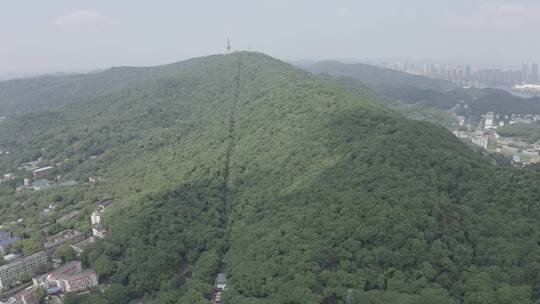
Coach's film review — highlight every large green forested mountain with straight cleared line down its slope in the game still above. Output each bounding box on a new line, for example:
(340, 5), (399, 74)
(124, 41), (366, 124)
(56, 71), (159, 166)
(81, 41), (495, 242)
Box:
(0, 52), (540, 304)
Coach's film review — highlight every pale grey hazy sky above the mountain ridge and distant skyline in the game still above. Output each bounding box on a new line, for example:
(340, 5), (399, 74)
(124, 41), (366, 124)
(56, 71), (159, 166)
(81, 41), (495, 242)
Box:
(0, 0), (540, 74)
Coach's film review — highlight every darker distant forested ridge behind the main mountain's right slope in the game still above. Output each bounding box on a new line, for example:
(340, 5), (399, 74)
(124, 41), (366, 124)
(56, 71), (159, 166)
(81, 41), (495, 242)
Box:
(306, 61), (540, 115)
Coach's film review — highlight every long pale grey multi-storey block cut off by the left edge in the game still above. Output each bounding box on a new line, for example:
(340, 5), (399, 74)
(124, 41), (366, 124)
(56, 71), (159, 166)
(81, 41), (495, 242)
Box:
(0, 251), (48, 288)
